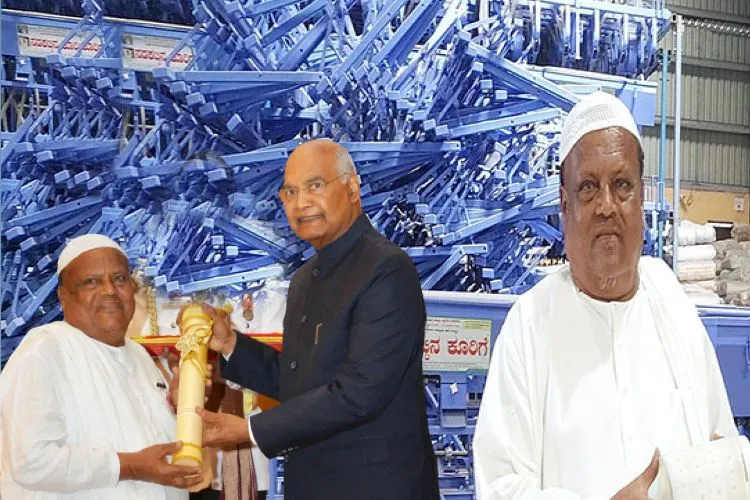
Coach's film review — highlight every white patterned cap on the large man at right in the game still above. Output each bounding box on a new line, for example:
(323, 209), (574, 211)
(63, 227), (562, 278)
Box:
(560, 91), (643, 163)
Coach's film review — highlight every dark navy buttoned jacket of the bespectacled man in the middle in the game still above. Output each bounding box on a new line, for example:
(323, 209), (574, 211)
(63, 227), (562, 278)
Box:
(221, 215), (439, 500)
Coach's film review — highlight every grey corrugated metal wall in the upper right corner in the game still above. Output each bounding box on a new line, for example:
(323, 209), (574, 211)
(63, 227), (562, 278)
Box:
(644, 0), (750, 187)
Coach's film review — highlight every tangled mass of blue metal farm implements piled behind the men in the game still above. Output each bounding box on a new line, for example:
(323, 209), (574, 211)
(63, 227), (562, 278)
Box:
(0, 0), (669, 360)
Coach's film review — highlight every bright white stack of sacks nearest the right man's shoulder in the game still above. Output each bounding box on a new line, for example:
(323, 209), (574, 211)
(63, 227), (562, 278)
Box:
(677, 220), (722, 304)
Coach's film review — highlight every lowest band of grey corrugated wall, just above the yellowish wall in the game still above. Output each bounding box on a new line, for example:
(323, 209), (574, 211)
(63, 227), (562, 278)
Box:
(643, 127), (750, 187)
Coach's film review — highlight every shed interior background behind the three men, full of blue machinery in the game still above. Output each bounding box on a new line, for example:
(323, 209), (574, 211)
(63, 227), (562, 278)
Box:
(0, 0), (750, 500)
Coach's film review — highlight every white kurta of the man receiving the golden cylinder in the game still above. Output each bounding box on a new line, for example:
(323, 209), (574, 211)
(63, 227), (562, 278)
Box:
(0, 322), (188, 500)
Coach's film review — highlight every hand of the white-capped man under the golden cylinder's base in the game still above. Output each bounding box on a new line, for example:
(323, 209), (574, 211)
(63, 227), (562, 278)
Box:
(117, 441), (203, 488)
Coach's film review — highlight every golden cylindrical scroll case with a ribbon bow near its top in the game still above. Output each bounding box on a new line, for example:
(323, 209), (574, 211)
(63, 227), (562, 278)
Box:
(172, 305), (213, 467)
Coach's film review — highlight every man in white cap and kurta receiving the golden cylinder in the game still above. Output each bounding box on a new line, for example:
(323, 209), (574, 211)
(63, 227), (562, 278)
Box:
(0, 234), (201, 500)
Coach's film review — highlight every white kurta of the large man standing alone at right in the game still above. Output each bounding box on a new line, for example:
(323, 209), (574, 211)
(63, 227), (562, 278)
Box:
(474, 258), (737, 500)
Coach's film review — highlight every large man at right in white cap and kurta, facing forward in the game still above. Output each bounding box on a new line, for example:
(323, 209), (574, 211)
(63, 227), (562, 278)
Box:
(474, 92), (737, 500)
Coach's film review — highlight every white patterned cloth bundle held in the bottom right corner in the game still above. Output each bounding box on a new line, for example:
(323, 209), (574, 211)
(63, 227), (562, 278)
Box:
(657, 436), (750, 500)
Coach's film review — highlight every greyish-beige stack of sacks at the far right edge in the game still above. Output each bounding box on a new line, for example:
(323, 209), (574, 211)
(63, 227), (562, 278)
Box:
(714, 224), (750, 306)
